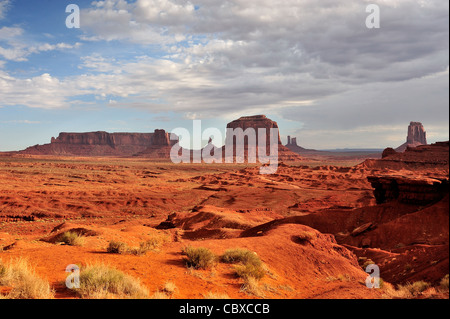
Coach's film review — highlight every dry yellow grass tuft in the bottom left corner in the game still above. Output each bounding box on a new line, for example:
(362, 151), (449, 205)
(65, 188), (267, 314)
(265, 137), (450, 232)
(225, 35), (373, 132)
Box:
(0, 258), (54, 299)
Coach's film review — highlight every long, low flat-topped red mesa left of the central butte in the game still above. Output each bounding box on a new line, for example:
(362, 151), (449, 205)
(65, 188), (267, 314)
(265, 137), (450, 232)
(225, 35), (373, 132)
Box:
(20, 130), (173, 157)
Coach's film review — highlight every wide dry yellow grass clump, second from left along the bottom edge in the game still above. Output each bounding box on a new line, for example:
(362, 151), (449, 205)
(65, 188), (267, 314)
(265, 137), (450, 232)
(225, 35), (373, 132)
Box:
(76, 264), (148, 299)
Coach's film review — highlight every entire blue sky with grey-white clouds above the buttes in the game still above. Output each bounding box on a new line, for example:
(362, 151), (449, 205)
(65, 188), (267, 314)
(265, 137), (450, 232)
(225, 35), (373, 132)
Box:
(0, 0), (449, 151)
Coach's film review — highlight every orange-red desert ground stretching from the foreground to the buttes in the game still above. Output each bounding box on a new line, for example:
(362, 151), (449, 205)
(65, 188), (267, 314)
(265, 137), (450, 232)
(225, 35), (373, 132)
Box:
(0, 145), (448, 298)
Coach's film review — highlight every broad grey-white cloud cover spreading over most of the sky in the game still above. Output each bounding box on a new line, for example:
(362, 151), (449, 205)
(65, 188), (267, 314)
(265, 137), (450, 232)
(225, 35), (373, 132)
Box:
(0, 0), (449, 147)
